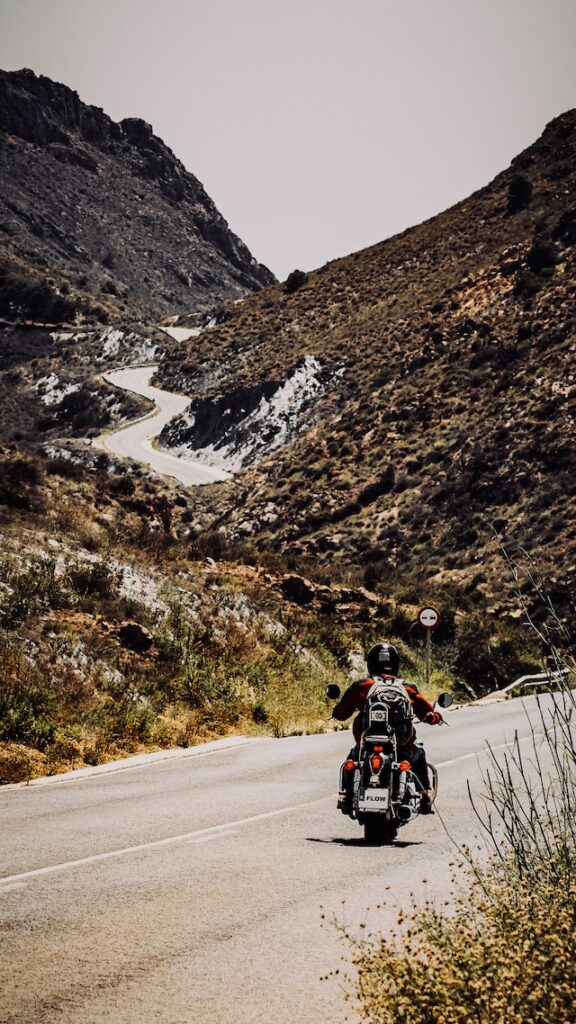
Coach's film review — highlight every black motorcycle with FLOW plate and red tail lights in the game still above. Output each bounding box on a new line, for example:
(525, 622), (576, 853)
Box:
(326, 683), (452, 846)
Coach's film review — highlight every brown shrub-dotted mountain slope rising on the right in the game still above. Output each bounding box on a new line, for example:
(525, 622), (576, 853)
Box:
(155, 112), (576, 606)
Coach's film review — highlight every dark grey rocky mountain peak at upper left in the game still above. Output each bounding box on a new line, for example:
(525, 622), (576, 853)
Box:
(0, 71), (274, 316)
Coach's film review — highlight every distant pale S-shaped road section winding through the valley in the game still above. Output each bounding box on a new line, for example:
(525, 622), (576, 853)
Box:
(93, 367), (231, 486)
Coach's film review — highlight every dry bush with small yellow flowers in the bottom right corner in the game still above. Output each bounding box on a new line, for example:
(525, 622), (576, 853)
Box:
(357, 862), (576, 1024)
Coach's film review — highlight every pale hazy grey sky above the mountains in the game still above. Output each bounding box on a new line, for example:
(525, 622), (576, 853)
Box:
(0, 0), (576, 279)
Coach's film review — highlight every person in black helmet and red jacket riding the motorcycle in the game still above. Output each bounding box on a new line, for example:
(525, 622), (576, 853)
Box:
(332, 642), (442, 814)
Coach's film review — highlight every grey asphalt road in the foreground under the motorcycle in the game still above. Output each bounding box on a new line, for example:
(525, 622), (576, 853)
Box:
(0, 697), (549, 1024)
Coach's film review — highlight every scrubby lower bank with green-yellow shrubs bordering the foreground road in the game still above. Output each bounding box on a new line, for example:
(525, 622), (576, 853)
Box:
(0, 445), (539, 782)
